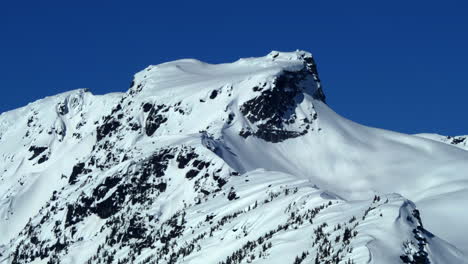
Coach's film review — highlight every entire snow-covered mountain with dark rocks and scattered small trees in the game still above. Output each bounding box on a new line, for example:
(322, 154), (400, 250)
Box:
(0, 51), (468, 264)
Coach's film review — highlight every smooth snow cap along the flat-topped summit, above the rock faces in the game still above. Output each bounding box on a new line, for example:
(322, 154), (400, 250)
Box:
(129, 50), (325, 101)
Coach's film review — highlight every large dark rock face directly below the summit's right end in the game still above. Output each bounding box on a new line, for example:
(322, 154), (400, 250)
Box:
(240, 69), (325, 143)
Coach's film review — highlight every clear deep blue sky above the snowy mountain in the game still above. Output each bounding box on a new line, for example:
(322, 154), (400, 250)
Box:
(0, 0), (468, 135)
